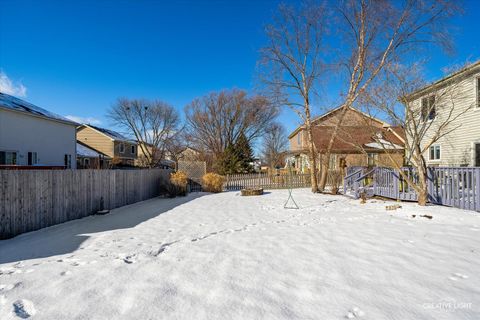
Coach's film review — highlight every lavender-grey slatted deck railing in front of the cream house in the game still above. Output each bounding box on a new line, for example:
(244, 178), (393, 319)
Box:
(344, 167), (480, 211)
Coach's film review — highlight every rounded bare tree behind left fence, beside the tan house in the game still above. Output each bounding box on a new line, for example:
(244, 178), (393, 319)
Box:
(108, 98), (180, 167)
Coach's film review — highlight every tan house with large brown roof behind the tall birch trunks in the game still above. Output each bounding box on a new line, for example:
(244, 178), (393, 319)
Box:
(288, 108), (405, 172)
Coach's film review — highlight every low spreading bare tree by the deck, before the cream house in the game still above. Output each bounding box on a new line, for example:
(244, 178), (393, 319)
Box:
(363, 64), (475, 205)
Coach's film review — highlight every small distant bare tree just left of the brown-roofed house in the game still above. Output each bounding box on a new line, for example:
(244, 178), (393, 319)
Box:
(262, 123), (288, 169)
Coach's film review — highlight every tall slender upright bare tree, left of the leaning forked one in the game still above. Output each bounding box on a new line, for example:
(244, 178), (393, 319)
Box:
(260, 2), (326, 192)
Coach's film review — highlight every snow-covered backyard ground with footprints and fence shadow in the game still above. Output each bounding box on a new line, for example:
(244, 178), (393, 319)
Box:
(0, 189), (480, 320)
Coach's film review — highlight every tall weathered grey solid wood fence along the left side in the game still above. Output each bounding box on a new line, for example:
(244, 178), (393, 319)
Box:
(0, 169), (170, 239)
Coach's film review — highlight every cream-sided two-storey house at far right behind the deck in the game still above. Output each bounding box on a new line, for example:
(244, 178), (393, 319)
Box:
(408, 61), (480, 167)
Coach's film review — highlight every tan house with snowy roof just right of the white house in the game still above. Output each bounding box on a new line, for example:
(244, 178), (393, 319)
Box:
(77, 124), (137, 166)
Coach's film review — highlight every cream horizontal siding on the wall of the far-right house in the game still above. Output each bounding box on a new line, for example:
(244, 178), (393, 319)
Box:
(413, 70), (480, 166)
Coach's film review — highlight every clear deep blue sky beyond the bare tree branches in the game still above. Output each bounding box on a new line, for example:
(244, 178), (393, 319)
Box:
(0, 0), (480, 130)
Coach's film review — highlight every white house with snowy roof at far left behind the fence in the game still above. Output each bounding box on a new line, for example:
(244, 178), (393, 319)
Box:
(0, 93), (78, 169)
